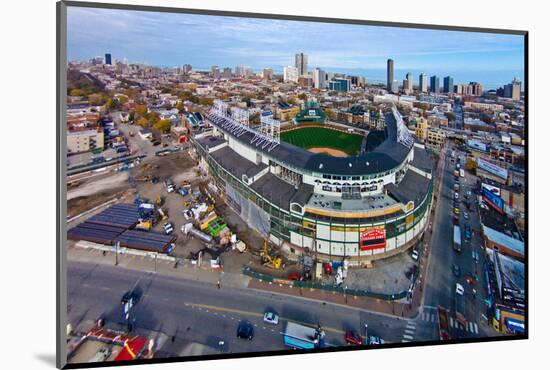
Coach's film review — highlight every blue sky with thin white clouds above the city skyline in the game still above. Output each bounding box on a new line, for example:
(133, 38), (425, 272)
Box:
(67, 7), (524, 87)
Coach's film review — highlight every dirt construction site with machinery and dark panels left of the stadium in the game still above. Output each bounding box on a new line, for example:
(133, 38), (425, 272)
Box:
(67, 145), (307, 279)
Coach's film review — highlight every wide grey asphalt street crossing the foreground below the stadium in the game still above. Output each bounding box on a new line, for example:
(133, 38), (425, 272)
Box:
(68, 261), (436, 355)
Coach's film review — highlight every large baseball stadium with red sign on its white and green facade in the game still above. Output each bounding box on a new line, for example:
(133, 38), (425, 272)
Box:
(191, 101), (433, 264)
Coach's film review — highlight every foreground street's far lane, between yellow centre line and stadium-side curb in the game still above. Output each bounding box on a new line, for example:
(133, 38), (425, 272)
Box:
(69, 263), (414, 344)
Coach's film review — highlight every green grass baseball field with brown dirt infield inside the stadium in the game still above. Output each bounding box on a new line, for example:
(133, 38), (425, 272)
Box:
(281, 127), (363, 156)
